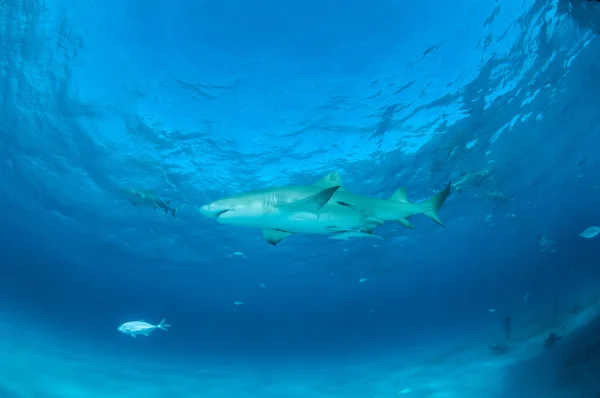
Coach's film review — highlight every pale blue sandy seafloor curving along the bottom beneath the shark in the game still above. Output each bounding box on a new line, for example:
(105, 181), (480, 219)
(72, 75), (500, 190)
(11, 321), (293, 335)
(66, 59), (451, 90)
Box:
(0, 292), (600, 398)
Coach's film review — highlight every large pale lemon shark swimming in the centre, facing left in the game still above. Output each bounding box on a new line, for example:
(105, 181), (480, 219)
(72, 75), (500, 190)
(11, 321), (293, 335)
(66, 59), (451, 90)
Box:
(199, 171), (450, 245)
